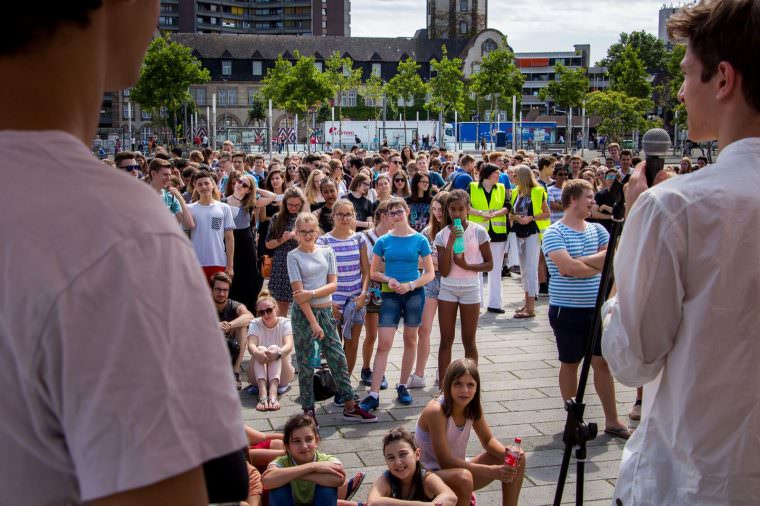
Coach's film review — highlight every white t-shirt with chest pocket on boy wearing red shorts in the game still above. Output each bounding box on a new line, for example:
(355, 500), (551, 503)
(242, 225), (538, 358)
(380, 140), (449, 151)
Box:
(188, 201), (235, 267)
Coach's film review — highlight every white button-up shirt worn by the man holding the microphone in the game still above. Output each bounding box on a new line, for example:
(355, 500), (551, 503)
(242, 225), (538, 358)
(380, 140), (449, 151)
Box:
(602, 138), (760, 506)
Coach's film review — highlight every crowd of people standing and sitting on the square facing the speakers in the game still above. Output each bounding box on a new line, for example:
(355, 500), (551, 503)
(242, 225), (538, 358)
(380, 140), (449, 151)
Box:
(114, 136), (701, 506)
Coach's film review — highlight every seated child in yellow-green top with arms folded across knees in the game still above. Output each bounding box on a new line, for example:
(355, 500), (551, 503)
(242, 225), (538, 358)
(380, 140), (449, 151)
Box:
(261, 415), (364, 506)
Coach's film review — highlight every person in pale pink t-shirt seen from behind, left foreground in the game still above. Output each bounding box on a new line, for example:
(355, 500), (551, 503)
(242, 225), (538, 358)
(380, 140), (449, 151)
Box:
(0, 0), (248, 506)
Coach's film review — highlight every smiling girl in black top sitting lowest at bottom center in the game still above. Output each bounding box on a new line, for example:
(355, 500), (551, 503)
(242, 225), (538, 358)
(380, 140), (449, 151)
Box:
(367, 427), (457, 506)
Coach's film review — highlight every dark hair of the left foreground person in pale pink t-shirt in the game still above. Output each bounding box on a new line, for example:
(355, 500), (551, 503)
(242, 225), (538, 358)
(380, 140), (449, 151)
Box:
(0, 0), (103, 56)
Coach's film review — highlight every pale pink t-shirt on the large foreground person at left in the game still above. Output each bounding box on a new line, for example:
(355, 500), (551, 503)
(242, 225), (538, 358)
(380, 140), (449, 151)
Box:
(0, 131), (246, 505)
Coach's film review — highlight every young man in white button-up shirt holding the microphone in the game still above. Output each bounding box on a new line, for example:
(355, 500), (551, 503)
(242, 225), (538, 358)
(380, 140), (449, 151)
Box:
(602, 0), (760, 506)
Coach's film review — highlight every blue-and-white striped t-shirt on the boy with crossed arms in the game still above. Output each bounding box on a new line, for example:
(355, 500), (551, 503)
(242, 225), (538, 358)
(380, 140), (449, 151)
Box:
(541, 222), (610, 307)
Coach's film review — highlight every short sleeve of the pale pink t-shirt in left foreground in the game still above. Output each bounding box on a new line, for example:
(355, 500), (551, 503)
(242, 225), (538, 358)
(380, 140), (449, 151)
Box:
(40, 233), (246, 502)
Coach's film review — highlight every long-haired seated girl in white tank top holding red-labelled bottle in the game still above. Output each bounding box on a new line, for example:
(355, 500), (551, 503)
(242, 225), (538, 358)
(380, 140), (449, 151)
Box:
(415, 358), (525, 506)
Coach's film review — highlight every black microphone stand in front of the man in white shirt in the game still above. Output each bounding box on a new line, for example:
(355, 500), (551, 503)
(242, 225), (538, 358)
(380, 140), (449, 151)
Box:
(554, 196), (625, 506)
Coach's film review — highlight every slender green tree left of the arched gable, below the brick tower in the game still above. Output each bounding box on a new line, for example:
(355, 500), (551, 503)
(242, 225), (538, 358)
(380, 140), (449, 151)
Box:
(425, 46), (464, 145)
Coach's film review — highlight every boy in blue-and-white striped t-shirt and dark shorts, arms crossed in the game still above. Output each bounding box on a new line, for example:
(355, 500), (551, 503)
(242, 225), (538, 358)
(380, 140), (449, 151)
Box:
(542, 179), (631, 439)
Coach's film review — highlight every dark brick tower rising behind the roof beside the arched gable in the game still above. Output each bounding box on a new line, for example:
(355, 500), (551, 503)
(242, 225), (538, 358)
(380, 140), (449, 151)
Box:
(427, 0), (488, 39)
